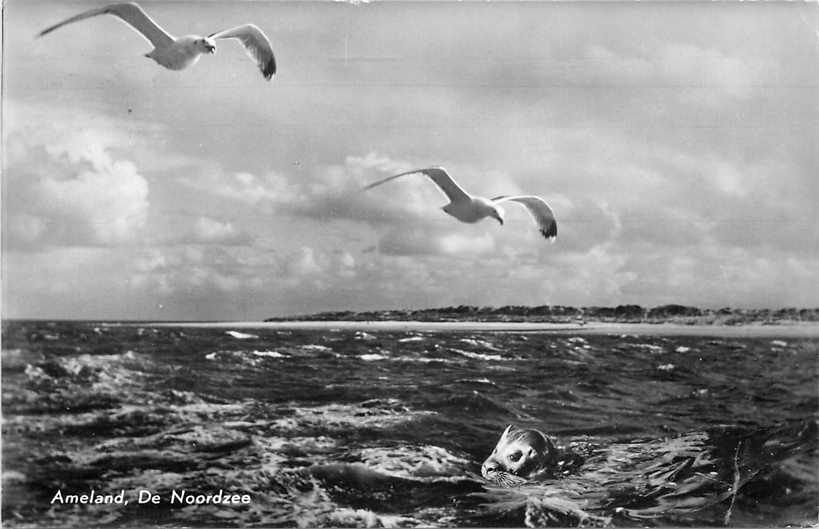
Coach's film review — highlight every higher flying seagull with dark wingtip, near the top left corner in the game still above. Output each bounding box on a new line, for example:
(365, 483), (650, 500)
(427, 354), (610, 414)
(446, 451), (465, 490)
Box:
(37, 2), (276, 81)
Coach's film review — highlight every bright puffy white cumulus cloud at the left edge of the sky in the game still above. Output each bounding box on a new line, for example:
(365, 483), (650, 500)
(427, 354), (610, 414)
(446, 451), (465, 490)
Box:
(3, 106), (149, 249)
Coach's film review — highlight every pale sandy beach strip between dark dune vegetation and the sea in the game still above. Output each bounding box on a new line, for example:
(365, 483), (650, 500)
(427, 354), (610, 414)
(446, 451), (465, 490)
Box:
(120, 320), (819, 338)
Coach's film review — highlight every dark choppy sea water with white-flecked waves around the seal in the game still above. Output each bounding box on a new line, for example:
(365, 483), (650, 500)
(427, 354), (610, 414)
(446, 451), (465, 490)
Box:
(2, 322), (819, 527)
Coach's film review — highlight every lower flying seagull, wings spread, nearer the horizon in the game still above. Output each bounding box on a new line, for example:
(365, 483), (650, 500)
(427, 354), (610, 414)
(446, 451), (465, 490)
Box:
(362, 167), (557, 240)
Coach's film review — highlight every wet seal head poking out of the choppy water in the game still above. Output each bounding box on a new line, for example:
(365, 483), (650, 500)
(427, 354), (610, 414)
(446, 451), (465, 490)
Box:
(481, 424), (557, 485)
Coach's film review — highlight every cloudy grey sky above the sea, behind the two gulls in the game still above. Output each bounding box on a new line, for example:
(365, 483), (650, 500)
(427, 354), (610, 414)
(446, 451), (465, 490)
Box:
(2, 0), (819, 320)
